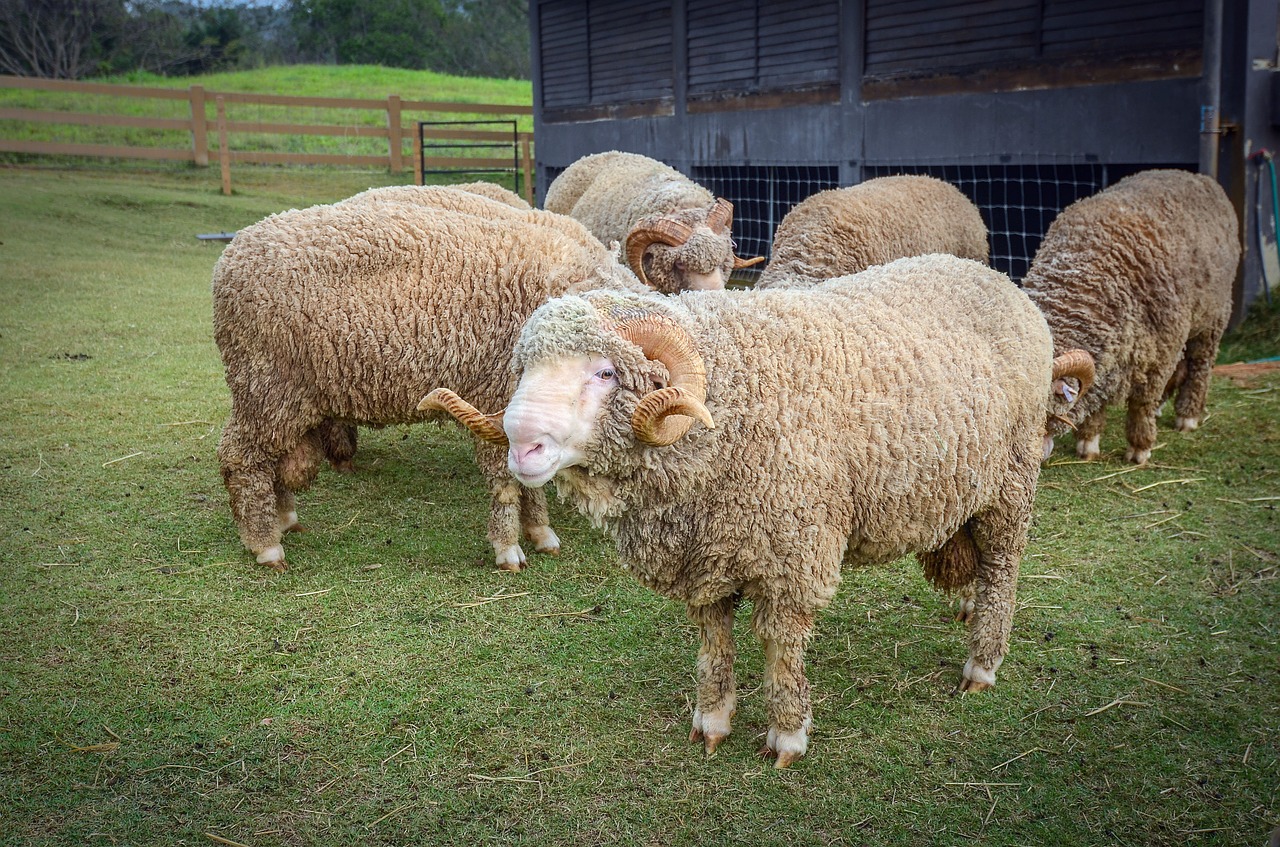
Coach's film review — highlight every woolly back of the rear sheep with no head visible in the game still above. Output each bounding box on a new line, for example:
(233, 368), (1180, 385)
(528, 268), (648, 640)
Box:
(755, 177), (988, 288)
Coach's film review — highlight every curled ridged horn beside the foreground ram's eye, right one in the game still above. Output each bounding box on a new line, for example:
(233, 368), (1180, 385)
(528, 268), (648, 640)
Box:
(612, 315), (716, 447)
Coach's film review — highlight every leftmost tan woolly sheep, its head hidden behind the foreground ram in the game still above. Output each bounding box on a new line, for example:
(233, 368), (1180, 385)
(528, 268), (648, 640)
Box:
(212, 198), (641, 571)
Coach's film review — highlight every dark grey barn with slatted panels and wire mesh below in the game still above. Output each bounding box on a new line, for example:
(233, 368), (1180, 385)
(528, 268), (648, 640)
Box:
(530, 0), (1280, 319)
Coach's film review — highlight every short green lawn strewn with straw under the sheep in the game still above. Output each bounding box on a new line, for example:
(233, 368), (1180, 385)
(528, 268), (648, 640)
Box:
(0, 169), (1280, 847)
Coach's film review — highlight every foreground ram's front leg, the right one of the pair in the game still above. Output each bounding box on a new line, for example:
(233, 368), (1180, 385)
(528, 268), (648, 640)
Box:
(751, 601), (814, 768)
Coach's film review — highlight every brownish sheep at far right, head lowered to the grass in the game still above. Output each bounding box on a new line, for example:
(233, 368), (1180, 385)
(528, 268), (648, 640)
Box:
(1023, 170), (1240, 464)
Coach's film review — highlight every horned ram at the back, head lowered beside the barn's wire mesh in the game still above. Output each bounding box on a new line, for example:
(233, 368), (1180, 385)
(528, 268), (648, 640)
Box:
(543, 150), (764, 294)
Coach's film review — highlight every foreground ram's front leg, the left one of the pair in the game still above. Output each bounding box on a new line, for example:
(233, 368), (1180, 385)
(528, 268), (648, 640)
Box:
(689, 598), (737, 756)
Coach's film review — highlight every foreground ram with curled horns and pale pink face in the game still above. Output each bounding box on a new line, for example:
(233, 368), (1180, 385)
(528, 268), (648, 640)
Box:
(424, 255), (1090, 768)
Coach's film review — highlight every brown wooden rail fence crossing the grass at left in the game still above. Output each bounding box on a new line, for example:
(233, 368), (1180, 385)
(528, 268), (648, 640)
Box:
(0, 75), (534, 203)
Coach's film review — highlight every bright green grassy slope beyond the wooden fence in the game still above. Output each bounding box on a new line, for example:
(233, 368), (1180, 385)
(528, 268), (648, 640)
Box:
(0, 65), (532, 170)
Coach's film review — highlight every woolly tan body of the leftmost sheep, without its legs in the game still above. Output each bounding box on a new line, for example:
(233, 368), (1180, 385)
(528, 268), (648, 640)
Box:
(212, 199), (608, 435)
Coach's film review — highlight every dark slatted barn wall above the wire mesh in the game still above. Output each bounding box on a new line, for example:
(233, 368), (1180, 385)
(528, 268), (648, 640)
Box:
(530, 0), (1280, 314)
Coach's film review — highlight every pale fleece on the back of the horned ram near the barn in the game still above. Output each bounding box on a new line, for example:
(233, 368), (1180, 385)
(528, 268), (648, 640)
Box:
(543, 150), (716, 244)
